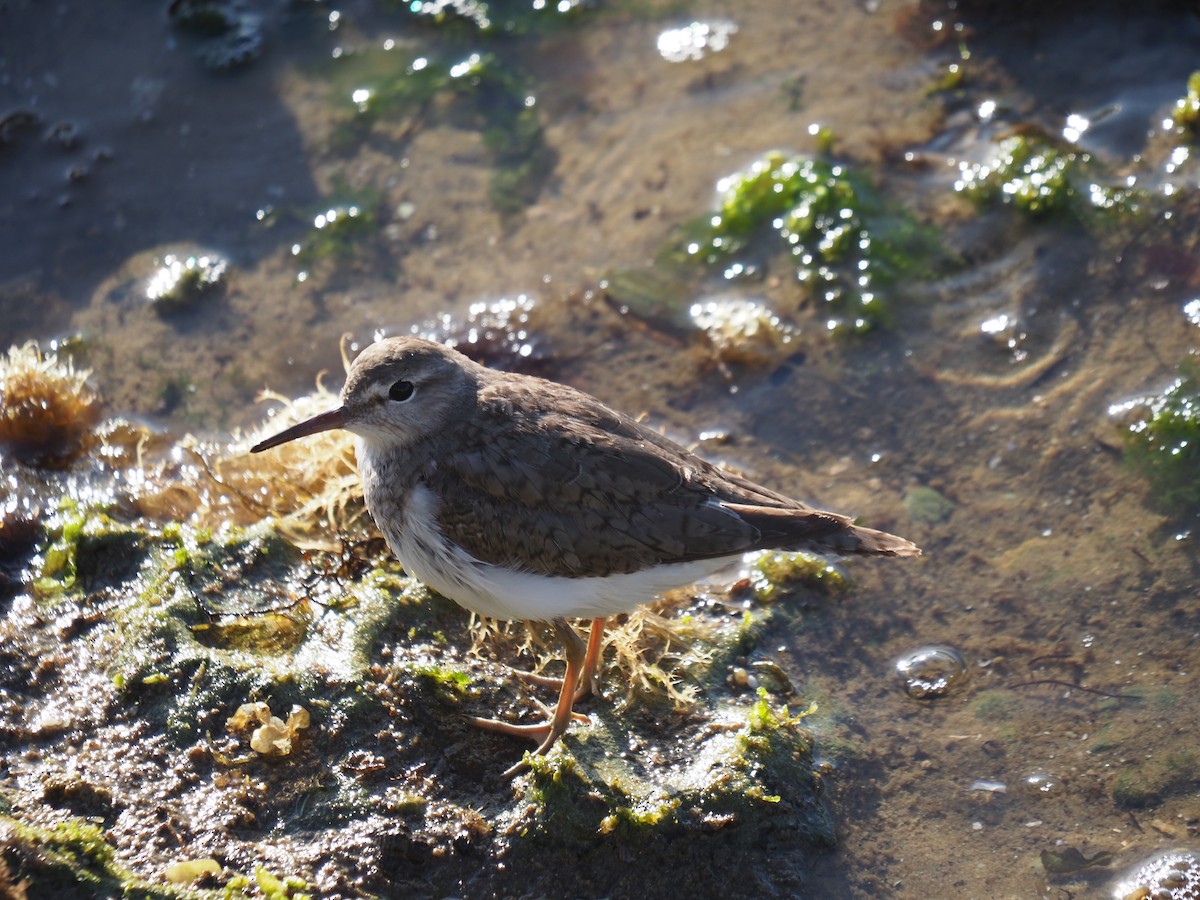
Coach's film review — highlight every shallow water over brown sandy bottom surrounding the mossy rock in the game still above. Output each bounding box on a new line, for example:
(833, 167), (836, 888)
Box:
(7, 0), (1200, 898)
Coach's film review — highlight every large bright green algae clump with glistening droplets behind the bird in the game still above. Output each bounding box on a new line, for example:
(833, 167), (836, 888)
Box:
(667, 151), (937, 335)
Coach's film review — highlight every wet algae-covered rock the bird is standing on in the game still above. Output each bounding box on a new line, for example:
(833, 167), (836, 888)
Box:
(0, 343), (840, 896)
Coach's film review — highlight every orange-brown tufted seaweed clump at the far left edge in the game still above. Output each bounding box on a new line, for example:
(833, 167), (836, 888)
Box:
(0, 341), (100, 468)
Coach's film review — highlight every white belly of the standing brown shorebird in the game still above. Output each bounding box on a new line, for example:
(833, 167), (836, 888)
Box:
(380, 485), (740, 620)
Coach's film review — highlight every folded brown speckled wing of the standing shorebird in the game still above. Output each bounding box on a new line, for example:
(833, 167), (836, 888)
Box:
(426, 380), (871, 577)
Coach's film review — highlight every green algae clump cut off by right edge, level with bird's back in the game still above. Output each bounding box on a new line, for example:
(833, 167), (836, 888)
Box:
(1114, 358), (1200, 512)
